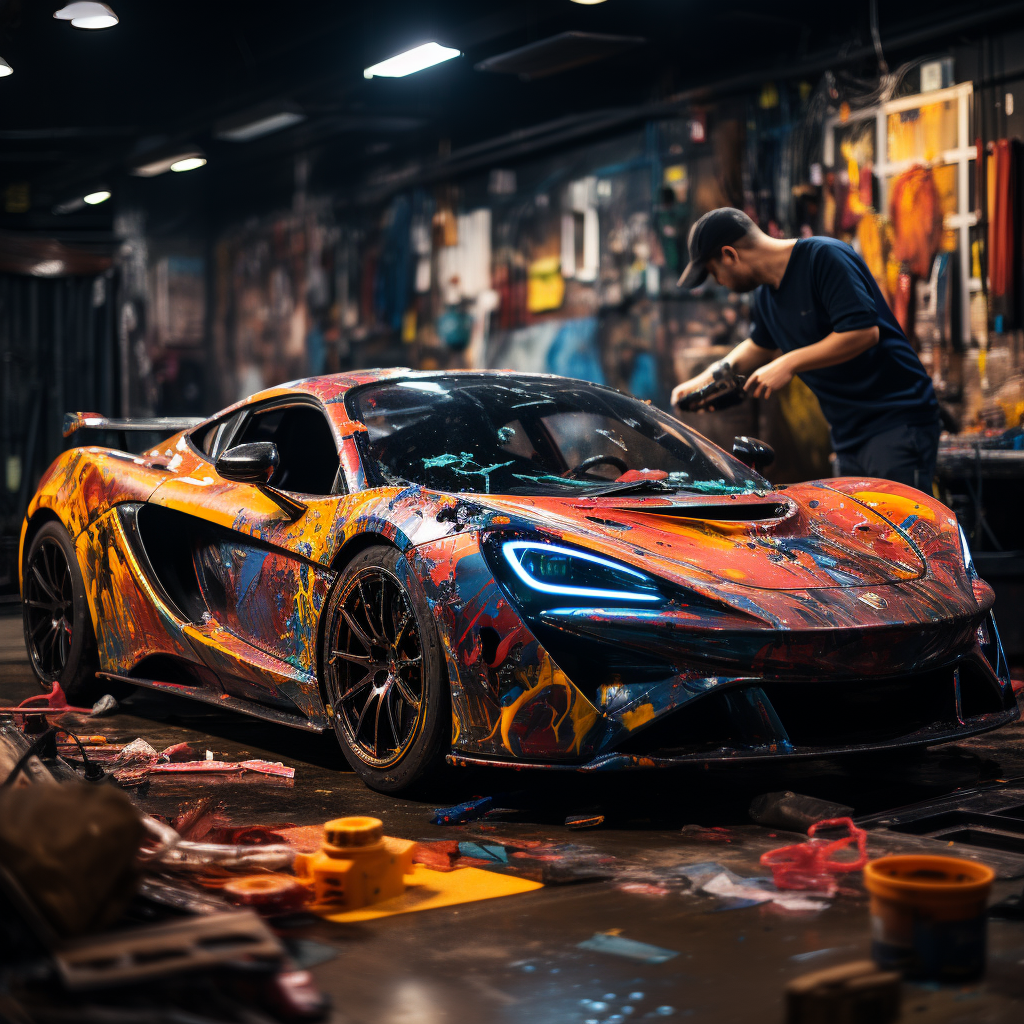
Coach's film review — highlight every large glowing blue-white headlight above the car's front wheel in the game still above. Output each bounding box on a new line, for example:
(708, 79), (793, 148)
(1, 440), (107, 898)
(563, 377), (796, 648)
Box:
(502, 541), (663, 601)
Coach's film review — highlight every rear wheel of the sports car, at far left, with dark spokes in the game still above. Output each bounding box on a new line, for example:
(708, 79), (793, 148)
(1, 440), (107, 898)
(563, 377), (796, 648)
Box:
(22, 522), (100, 705)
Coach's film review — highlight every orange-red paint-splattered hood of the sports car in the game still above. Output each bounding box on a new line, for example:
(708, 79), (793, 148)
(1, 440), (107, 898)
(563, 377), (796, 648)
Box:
(476, 483), (927, 591)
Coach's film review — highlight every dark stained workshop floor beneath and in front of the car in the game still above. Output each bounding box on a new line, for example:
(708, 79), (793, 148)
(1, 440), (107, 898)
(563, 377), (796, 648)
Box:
(0, 609), (1024, 1024)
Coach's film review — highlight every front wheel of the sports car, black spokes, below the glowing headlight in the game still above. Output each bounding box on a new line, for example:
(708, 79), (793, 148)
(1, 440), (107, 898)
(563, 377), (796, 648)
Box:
(321, 545), (452, 793)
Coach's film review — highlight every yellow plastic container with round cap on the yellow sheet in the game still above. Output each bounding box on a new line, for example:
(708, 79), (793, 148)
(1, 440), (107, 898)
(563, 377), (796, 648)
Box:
(295, 816), (416, 910)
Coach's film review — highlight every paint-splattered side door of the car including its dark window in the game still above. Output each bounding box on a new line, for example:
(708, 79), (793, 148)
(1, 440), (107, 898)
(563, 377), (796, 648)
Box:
(146, 396), (345, 716)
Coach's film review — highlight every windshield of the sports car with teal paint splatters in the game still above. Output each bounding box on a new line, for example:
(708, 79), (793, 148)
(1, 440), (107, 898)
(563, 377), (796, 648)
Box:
(346, 374), (766, 495)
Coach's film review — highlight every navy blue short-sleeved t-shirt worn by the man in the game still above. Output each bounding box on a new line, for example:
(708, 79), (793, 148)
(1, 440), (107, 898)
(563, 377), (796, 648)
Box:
(751, 237), (939, 452)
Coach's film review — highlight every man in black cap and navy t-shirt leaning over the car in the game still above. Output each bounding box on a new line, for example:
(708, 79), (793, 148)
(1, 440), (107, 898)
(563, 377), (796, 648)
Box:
(672, 208), (941, 490)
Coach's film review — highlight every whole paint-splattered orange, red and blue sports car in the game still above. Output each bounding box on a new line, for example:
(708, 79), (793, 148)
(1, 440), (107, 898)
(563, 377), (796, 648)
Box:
(20, 370), (1018, 792)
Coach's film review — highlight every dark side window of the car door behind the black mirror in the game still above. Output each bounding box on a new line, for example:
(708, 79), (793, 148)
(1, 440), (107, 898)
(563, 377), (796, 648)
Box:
(231, 406), (338, 495)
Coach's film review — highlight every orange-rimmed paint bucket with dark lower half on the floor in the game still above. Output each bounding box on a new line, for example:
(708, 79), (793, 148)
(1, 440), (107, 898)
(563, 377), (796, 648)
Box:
(864, 854), (995, 981)
